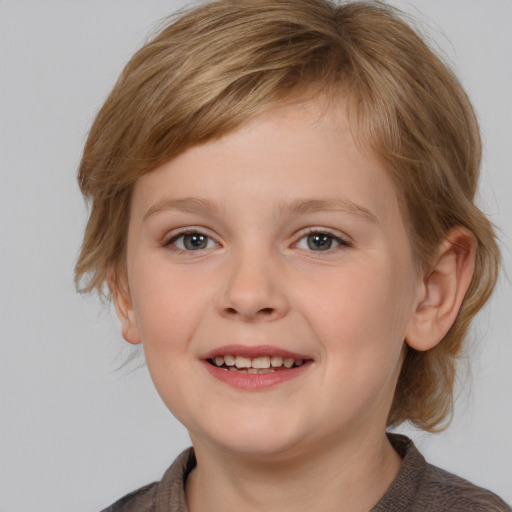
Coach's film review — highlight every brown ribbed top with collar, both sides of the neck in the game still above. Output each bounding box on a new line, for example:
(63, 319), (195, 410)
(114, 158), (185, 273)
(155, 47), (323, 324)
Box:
(103, 434), (512, 512)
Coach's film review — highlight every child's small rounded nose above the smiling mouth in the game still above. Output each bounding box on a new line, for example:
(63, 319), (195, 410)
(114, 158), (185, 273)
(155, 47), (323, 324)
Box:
(218, 248), (289, 322)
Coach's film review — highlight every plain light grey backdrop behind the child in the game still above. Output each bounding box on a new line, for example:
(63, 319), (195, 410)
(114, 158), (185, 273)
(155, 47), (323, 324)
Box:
(0, 0), (512, 512)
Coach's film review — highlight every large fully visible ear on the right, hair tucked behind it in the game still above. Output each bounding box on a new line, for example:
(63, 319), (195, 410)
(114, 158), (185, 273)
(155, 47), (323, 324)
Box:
(405, 226), (476, 351)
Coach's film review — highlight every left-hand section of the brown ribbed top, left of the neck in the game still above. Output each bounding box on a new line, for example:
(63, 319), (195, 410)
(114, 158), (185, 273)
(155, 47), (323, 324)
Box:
(102, 448), (196, 512)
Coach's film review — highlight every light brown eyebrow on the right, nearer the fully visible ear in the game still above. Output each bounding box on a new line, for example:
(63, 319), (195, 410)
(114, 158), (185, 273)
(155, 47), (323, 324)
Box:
(278, 197), (378, 224)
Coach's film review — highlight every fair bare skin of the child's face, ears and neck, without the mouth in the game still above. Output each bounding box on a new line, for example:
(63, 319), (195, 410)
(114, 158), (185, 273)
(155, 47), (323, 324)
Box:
(111, 100), (471, 512)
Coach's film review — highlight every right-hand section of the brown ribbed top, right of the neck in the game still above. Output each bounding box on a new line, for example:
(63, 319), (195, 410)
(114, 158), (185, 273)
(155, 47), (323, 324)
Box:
(372, 434), (512, 512)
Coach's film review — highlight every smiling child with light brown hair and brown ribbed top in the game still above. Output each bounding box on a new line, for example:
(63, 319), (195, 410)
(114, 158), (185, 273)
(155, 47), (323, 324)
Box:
(76, 0), (510, 512)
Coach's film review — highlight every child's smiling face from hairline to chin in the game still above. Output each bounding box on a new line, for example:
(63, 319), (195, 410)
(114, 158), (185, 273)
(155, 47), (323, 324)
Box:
(116, 98), (421, 454)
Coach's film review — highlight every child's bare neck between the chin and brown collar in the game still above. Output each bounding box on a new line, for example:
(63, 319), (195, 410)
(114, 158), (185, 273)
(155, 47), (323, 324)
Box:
(186, 434), (401, 512)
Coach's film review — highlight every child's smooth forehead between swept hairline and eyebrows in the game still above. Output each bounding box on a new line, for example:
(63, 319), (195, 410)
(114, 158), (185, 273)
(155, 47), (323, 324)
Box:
(133, 98), (404, 228)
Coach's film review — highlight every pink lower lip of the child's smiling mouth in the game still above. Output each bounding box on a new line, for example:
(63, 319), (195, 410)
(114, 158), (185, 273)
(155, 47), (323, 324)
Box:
(202, 361), (311, 391)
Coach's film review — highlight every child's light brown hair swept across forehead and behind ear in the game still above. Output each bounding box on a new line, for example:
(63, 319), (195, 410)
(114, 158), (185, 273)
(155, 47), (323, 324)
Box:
(76, 0), (499, 430)
